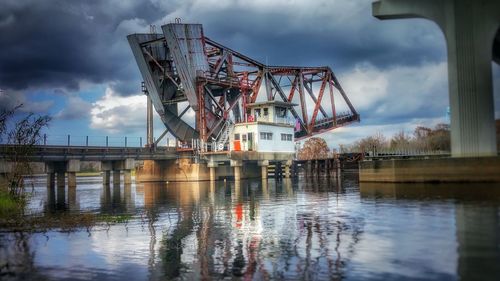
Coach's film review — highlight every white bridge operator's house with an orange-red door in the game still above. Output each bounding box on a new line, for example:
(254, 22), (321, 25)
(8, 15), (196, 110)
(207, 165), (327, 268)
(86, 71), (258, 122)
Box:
(230, 101), (295, 153)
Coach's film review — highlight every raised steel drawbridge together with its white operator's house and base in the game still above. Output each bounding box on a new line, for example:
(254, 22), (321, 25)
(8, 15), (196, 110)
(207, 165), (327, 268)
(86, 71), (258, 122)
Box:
(127, 20), (360, 180)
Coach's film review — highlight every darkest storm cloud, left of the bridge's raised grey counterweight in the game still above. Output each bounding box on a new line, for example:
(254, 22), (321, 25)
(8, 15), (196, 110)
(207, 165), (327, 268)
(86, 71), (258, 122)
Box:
(0, 0), (170, 93)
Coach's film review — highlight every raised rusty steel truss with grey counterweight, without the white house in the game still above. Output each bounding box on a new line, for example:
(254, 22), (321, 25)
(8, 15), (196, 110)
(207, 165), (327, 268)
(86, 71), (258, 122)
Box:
(128, 23), (360, 141)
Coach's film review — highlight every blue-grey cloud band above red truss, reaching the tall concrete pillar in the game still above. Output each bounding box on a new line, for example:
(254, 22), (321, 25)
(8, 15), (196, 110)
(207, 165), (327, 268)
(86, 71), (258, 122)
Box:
(191, 1), (446, 71)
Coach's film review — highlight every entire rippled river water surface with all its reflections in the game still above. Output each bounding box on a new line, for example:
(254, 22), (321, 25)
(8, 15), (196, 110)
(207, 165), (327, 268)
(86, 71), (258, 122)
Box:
(0, 174), (500, 280)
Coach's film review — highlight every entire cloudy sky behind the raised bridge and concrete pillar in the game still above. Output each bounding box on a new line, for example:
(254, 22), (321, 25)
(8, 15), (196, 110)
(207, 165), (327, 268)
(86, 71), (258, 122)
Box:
(0, 0), (500, 148)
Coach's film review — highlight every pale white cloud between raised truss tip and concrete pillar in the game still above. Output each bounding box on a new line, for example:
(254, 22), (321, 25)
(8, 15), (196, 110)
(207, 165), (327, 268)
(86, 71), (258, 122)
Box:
(340, 62), (449, 124)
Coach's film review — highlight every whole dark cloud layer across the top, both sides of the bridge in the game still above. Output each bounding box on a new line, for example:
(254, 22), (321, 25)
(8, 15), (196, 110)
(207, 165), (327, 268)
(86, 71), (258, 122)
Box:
(0, 0), (444, 94)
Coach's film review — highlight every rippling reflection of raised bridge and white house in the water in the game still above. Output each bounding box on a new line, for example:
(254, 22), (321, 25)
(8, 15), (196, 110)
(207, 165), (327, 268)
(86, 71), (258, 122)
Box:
(139, 180), (362, 279)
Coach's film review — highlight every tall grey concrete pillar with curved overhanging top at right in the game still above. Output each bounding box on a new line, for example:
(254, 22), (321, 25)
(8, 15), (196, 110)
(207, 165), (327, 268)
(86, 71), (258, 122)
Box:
(373, 0), (500, 157)
